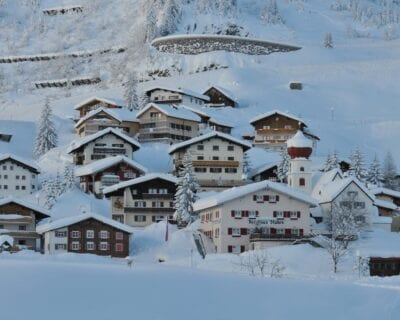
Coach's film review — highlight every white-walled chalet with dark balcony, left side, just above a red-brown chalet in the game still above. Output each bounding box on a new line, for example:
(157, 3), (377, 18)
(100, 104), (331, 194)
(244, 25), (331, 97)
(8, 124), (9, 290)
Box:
(68, 128), (140, 165)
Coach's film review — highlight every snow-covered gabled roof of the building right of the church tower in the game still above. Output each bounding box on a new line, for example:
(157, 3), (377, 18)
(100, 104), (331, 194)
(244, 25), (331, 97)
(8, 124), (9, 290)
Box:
(312, 177), (375, 203)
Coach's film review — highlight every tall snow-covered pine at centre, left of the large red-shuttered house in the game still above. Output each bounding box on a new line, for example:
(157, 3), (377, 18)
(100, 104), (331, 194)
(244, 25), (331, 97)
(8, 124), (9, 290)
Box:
(174, 153), (199, 224)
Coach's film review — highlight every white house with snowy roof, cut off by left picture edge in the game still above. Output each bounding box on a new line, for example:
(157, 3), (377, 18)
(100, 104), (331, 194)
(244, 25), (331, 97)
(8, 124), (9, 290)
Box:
(0, 154), (40, 197)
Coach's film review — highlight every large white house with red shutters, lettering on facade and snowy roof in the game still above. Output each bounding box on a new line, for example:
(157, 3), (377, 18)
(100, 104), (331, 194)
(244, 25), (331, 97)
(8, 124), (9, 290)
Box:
(194, 181), (318, 253)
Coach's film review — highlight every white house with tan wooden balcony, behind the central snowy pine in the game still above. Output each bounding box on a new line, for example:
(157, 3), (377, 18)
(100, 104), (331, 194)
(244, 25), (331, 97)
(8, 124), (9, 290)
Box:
(168, 131), (251, 190)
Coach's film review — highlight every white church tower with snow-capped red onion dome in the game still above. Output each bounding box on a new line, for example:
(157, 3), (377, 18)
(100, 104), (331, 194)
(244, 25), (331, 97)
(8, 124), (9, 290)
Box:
(286, 130), (313, 194)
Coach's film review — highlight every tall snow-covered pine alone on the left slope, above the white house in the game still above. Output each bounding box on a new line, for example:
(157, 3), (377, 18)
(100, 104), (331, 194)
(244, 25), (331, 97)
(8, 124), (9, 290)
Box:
(34, 98), (58, 157)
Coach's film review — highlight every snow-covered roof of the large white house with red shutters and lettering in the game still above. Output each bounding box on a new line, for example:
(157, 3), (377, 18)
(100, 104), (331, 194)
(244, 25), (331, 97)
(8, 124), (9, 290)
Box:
(194, 181), (318, 211)
